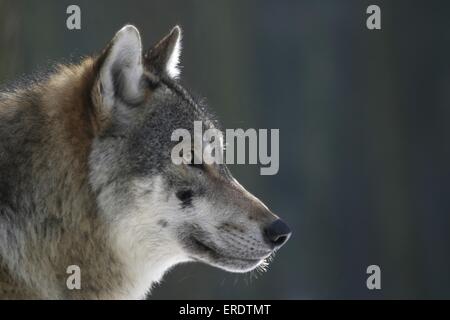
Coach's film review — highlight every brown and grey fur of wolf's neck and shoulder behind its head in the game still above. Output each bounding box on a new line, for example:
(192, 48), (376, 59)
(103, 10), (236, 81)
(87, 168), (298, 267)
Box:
(0, 59), (150, 299)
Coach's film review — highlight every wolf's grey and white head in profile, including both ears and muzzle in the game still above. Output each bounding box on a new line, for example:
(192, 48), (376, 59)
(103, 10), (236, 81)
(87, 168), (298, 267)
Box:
(89, 26), (290, 288)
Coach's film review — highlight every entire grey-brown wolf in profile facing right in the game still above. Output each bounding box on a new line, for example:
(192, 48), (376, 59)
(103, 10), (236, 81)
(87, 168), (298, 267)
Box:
(0, 25), (291, 299)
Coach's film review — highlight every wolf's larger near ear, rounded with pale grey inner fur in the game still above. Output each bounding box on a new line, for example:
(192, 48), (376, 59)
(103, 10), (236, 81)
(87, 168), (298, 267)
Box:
(99, 25), (144, 108)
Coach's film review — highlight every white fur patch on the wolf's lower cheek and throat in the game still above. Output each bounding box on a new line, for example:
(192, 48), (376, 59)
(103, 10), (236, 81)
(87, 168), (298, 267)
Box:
(106, 176), (188, 299)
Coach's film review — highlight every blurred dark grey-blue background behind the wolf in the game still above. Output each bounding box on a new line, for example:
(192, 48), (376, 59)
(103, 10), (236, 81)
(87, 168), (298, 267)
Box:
(0, 0), (450, 299)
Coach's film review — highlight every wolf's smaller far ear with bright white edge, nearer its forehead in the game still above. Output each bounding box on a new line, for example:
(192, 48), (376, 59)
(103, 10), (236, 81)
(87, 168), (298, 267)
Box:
(145, 26), (181, 78)
